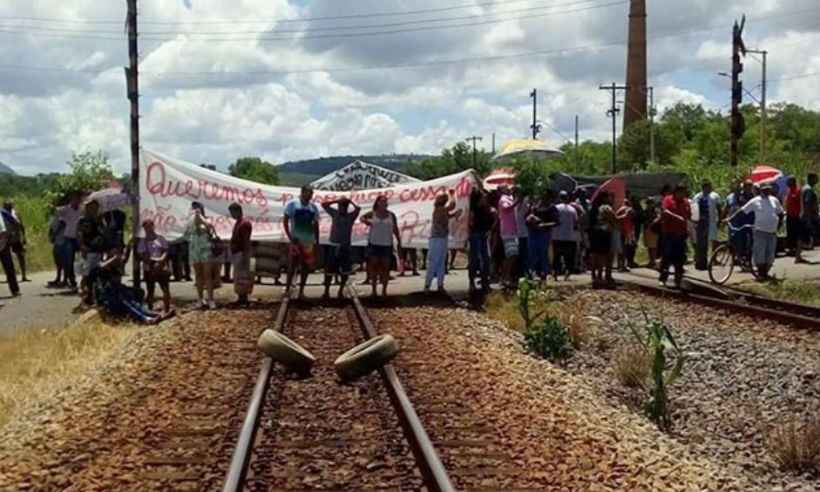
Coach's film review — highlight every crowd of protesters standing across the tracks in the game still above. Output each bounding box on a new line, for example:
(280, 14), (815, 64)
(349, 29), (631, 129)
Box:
(0, 173), (820, 323)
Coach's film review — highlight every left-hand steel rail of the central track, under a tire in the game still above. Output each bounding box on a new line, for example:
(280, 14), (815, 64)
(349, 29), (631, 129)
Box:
(222, 295), (290, 492)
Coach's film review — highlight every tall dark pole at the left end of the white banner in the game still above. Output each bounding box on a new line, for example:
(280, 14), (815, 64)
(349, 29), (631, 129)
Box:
(125, 0), (141, 287)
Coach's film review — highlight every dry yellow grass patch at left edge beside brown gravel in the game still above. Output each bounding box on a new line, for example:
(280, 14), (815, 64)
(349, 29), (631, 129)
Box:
(0, 322), (135, 428)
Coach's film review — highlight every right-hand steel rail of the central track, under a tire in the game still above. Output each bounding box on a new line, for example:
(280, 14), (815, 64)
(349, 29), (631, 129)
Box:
(348, 287), (455, 492)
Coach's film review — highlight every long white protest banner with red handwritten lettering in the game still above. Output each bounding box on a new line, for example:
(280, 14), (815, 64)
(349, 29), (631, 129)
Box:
(139, 150), (477, 248)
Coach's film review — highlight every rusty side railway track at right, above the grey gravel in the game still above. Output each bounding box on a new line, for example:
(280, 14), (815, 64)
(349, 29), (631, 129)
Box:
(620, 274), (820, 331)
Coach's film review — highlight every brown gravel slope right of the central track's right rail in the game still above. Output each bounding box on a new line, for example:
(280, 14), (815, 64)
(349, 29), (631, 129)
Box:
(371, 308), (750, 491)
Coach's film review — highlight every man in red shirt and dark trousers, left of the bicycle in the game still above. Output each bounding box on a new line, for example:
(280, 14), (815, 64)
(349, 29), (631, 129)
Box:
(660, 184), (692, 289)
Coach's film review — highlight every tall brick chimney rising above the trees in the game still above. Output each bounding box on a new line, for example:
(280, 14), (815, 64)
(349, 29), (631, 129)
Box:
(624, 0), (647, 129)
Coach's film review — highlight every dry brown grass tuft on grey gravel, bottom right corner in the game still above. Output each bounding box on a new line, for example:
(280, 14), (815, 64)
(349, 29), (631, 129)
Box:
(768, 416), (820, 472)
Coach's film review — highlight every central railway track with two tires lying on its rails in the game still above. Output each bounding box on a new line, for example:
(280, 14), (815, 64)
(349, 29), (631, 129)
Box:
(223, 296), (454, 491)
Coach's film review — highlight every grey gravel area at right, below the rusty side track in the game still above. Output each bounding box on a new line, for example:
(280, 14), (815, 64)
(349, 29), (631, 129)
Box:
(565, 292), (820, 491)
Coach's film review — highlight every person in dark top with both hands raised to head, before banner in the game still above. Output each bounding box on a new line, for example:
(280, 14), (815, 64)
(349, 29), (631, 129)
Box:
(322, 197), (358, 299)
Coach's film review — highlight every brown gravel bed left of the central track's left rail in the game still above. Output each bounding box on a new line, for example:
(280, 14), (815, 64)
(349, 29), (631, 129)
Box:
(0, 309), (272, 491)
